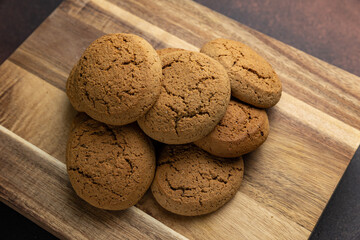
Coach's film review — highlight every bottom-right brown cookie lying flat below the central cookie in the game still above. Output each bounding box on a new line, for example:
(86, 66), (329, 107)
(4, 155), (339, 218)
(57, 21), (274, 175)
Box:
(151, 144), (244, 216)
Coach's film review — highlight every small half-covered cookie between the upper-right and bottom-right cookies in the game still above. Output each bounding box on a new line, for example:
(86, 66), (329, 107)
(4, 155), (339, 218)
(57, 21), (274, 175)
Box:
(194, 100), (270, 158)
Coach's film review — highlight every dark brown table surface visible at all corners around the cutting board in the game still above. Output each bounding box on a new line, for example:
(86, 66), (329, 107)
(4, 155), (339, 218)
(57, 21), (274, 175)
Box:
(0, 0), (360, 239)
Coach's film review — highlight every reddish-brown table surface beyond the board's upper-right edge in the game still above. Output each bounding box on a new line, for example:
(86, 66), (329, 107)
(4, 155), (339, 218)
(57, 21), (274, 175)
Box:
(196, 0), (360, 76)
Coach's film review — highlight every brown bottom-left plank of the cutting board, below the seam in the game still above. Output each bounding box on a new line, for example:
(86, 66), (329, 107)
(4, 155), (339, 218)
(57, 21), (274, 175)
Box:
(0, 126), (185, 239)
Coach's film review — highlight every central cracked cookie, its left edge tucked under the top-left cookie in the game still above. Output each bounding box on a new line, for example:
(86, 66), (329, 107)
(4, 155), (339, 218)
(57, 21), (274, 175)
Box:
(138, 50), (231, 144)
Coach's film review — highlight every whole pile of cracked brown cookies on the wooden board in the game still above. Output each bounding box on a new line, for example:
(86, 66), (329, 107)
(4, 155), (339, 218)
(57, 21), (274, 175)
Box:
(66, 34), (281, 216)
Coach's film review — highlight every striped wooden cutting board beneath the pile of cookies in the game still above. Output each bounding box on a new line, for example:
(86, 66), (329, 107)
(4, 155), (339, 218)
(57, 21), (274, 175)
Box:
(0, 0), (360, 239)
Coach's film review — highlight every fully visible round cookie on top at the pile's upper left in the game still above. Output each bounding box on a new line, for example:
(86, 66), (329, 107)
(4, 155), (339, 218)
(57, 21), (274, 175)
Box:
(67, 33), (161, 125)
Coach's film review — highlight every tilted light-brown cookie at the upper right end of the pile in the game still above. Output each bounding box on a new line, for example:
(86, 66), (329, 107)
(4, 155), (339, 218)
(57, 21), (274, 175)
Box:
(200, 39), (282, 108)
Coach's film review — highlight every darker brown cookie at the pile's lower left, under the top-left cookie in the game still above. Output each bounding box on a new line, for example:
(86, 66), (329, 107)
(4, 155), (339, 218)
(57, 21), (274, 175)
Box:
(66, 114), (156, 210)
